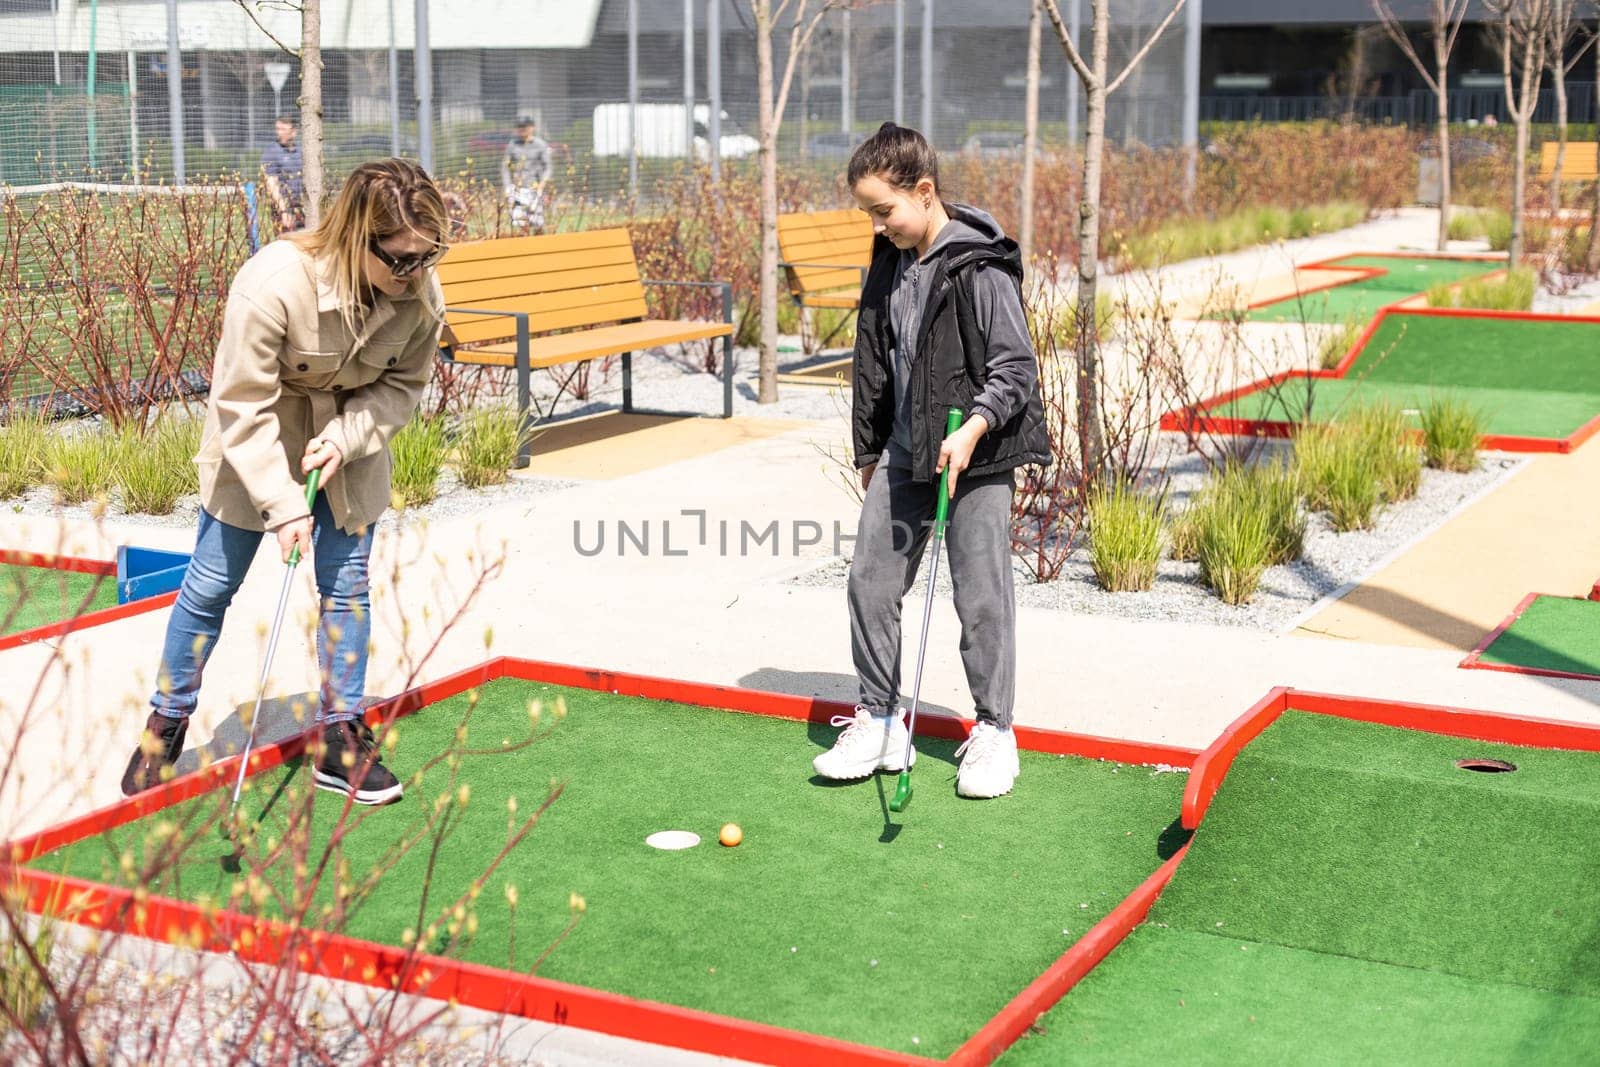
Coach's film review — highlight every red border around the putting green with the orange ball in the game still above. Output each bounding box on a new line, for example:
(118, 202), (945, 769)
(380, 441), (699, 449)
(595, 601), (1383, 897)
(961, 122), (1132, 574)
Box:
(0, 656), (1198, 1067)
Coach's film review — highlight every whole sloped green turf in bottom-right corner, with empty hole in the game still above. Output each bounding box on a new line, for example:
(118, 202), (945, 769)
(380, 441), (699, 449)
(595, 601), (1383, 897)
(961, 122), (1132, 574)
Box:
(992, 712), (1600, 1064)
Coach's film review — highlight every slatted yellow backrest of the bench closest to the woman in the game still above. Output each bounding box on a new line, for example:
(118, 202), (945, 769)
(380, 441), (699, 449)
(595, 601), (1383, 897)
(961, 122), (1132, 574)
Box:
(438, 227), (648, 344)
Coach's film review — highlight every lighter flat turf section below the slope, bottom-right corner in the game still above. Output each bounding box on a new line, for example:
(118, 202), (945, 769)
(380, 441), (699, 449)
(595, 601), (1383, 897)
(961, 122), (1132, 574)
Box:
(1000, 926), (1600, 1067)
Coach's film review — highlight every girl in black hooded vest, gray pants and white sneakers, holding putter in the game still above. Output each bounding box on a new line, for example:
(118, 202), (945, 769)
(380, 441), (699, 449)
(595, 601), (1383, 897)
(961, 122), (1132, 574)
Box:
(813, 123), (1051, 797)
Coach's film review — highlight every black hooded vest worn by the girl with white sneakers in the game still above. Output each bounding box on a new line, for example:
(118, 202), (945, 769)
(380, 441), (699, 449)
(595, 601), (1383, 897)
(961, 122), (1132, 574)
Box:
(853, 205), (1051, 482)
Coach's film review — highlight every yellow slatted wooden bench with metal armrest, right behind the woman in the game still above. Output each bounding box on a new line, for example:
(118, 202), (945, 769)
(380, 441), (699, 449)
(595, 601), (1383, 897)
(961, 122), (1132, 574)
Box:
(438, 227), (733, 467)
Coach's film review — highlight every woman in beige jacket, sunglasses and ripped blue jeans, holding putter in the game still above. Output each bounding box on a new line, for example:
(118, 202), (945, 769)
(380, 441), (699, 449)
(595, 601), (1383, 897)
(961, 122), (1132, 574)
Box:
(122, 160), (450, 805)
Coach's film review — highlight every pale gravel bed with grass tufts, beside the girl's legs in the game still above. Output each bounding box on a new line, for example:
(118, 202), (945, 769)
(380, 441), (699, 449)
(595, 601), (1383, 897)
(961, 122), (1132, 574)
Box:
(790, 438), (1528, 632)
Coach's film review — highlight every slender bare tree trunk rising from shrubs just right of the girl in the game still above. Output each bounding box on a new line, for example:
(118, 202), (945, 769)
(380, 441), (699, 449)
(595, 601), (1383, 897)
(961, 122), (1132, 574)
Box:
(1077, 0), (1110, 483)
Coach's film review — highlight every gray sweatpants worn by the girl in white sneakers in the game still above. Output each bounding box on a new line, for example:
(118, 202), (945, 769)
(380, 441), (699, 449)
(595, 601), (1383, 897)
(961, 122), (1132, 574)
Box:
(850, 466), (1016, 728)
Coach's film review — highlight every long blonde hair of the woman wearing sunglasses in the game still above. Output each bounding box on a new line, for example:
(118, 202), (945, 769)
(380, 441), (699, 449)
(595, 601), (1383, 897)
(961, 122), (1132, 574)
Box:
(290, 158), (450, 333)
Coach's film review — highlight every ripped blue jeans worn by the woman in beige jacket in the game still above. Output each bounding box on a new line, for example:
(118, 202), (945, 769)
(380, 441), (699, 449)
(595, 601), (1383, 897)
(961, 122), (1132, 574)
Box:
(150, 493), (373, 723)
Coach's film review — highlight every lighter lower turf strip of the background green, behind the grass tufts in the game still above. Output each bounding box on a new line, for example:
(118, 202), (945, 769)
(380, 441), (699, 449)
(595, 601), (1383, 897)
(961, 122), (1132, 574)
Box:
(1210, 378), (1600, 440)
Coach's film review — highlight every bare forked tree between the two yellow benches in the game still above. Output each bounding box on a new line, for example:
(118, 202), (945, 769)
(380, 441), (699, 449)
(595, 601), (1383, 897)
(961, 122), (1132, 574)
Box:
(750, 0), (867, 403)
